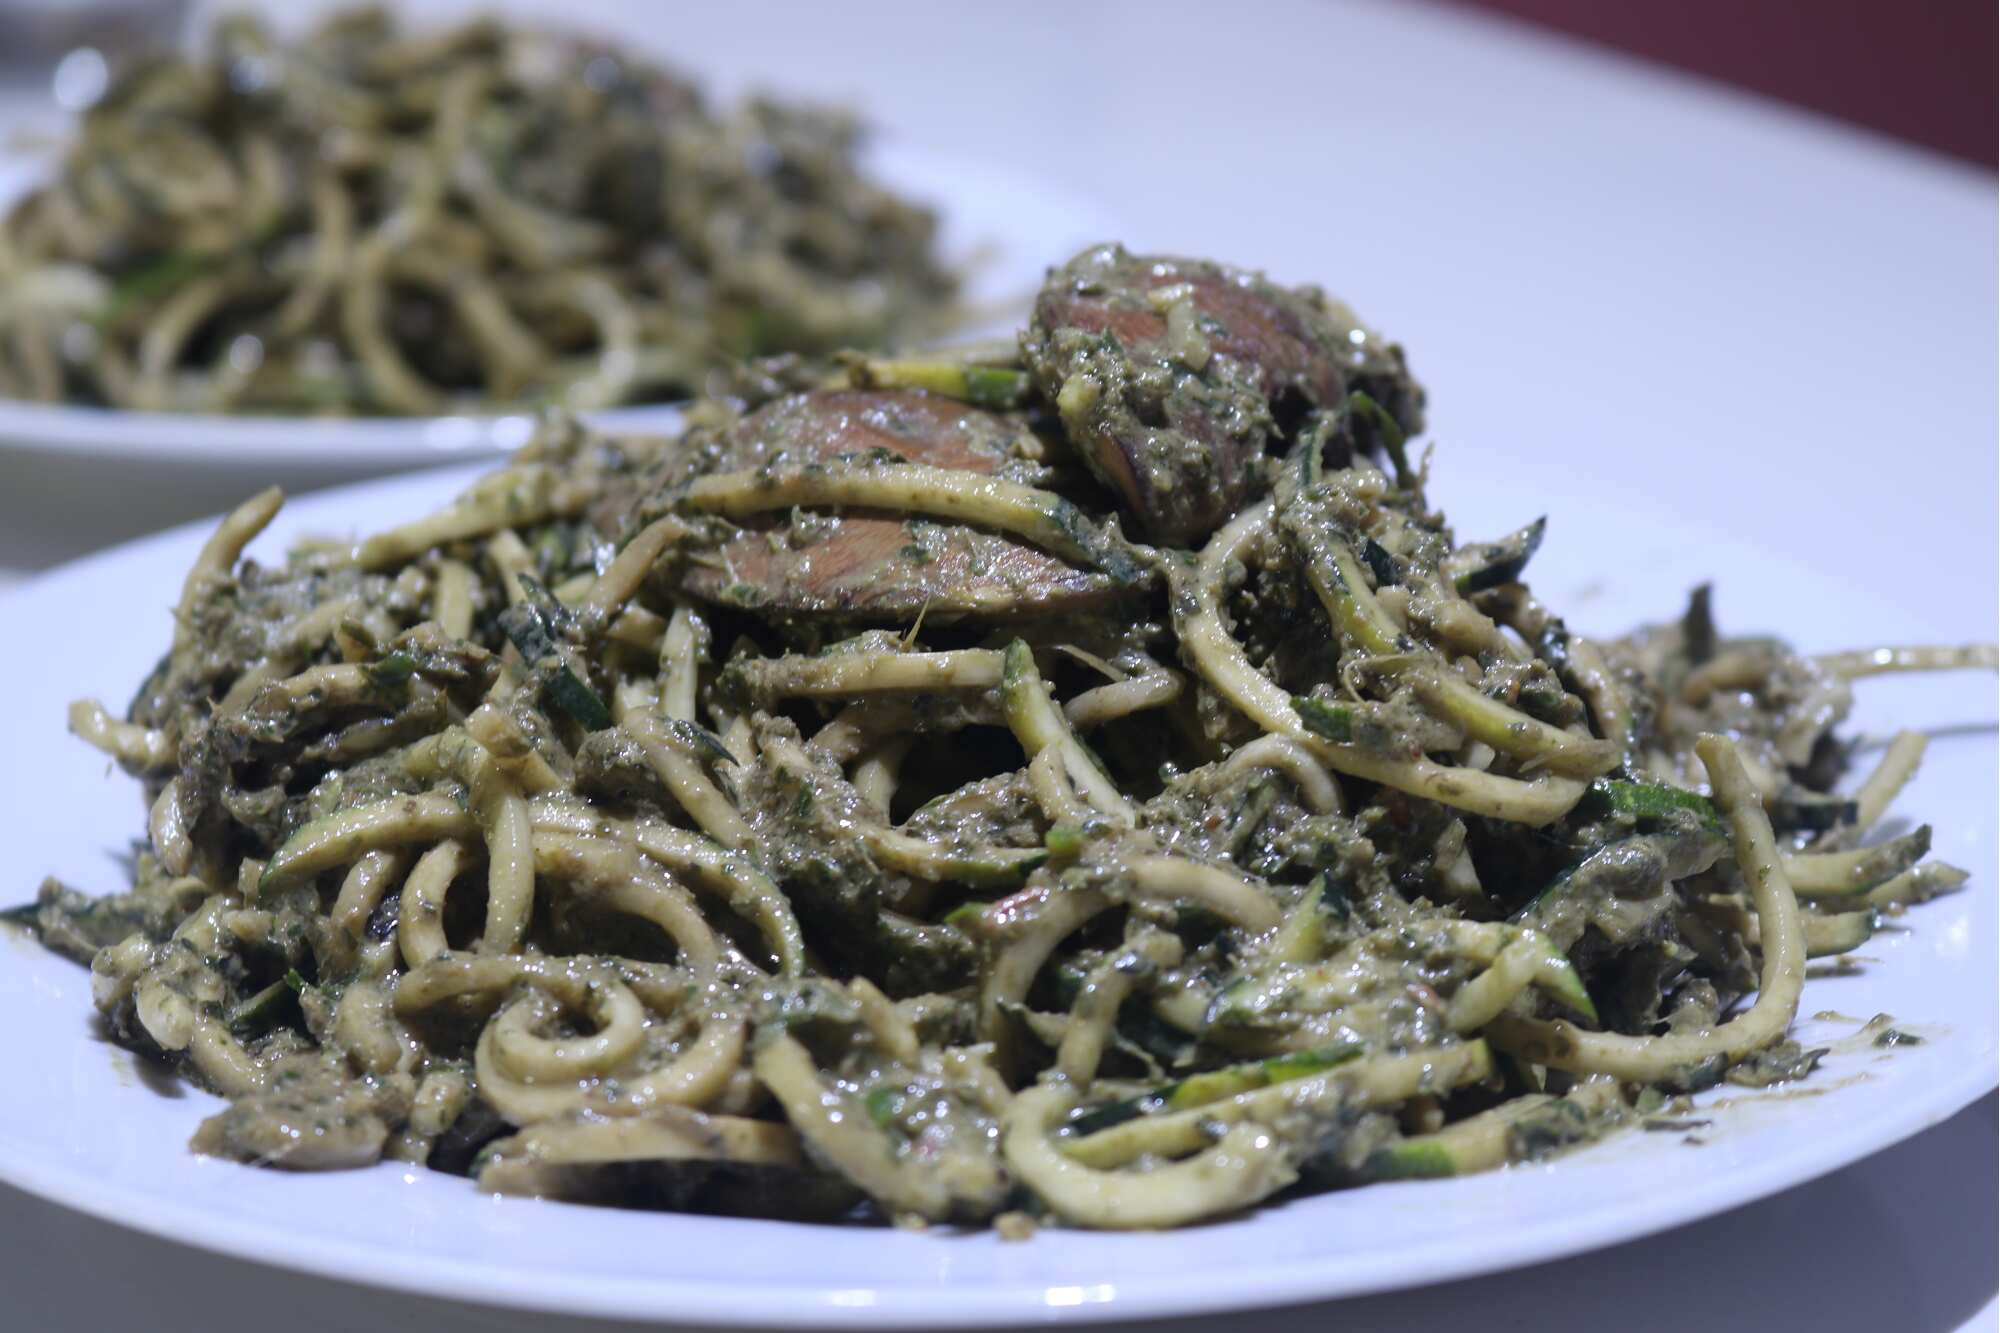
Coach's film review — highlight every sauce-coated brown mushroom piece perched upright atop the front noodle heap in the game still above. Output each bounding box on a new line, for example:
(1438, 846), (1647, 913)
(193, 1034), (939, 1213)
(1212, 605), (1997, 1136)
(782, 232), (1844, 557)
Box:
(1022, 244), (1424, 546)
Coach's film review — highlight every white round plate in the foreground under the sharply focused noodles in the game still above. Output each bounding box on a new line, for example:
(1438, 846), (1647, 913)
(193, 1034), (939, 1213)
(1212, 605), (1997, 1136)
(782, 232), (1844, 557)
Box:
(0, 452), (2000, 1327)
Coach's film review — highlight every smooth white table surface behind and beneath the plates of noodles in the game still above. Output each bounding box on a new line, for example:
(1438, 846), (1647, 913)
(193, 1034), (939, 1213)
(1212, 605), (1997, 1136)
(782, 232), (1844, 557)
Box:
(0, 0), (2000, 1333)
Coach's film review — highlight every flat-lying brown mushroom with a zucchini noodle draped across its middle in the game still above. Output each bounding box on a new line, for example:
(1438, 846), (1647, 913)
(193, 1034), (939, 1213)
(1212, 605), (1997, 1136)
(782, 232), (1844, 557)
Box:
(676, 388), (1126, 622)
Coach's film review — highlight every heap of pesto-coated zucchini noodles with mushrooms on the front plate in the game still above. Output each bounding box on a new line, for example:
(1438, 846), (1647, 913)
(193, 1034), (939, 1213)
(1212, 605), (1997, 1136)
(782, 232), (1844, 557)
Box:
(8, 239), (1992, 1233)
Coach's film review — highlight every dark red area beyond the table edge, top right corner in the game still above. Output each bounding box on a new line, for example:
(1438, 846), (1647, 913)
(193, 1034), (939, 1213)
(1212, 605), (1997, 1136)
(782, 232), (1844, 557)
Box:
(1458, 0), (2000, 170)
